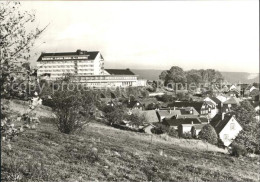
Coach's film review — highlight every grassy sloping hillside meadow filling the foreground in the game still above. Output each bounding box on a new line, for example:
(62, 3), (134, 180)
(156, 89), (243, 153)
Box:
(1, 100), (259, 182)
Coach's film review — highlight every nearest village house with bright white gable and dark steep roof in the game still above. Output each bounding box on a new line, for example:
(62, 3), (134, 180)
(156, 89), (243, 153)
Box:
(210, 112), (242, 147)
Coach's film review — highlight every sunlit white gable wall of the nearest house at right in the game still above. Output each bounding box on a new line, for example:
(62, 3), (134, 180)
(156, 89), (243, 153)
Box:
(219, 117), (242, 146)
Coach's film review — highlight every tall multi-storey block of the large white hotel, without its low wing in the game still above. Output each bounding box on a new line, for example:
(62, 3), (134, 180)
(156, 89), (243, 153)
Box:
(37, 50), (104, 80)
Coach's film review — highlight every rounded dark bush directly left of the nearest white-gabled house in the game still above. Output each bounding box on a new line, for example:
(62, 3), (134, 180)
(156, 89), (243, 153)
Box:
(199, 124), (218, 145)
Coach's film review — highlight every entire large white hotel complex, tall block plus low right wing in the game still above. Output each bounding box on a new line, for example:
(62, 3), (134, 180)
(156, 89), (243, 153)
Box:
(37, 50), (146, 87)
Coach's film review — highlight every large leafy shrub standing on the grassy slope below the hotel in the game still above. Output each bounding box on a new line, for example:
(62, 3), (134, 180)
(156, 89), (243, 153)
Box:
(53, 90), (95, 134)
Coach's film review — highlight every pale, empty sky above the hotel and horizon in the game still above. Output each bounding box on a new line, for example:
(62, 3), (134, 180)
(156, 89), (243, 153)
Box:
(22, 0), (259, 73)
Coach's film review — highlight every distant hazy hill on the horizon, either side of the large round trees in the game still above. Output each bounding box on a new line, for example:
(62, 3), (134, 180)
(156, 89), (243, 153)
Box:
(131, 69), (259, 83)
